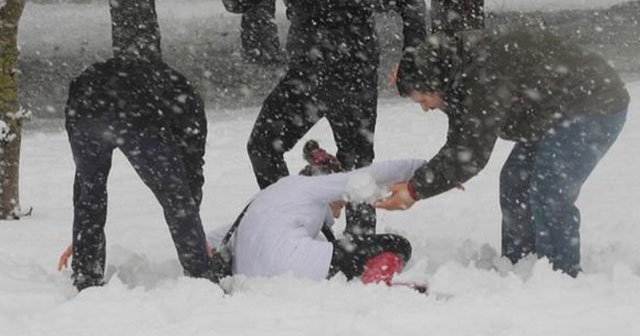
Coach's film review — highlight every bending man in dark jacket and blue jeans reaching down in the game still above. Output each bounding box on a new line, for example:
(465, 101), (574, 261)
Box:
(390, 28), (629, 276)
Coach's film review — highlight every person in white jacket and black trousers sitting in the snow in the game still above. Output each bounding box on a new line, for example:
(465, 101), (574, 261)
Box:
(208, 140), (424, 285)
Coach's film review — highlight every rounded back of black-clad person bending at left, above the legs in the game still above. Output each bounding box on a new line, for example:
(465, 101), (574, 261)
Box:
(66, 58), (202, 127)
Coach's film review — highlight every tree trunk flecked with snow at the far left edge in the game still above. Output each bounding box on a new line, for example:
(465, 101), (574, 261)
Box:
(0, 0), (24, 219)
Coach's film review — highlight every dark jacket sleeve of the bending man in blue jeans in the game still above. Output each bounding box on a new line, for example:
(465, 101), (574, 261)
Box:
(409, 101), (498, 199)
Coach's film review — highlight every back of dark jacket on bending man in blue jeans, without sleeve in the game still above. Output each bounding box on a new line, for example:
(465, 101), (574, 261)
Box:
(461, 28), (629, 140)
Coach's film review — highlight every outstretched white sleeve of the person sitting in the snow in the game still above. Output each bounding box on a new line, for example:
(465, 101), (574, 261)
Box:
(303, 160), (426, 202)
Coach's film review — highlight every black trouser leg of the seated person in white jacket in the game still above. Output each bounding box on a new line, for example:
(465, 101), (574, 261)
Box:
(329, 234), (411, 280)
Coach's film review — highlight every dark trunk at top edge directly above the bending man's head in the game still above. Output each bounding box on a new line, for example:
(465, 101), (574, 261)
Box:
(431, 0), (484, 35)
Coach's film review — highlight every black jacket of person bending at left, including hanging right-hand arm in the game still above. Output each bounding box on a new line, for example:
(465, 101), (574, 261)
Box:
(65, 58), (207, 203)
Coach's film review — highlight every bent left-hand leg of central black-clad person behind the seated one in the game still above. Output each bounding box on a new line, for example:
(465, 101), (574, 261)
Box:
(247, 70), (324, 189)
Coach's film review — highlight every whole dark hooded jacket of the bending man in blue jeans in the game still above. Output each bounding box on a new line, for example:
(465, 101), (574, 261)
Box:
(410, 28), (629, 199)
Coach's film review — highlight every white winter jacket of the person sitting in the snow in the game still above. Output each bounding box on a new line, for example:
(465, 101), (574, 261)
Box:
(207, 160), (425, 280)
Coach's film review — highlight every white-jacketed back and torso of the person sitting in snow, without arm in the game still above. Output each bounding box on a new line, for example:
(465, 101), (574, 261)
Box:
(233, 176), (333, 279)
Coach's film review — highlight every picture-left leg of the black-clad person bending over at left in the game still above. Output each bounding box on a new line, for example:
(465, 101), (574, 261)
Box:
(67, 119), (114, 289)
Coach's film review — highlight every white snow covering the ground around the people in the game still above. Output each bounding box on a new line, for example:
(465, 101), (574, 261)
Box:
(0, 82), (640, 336)
